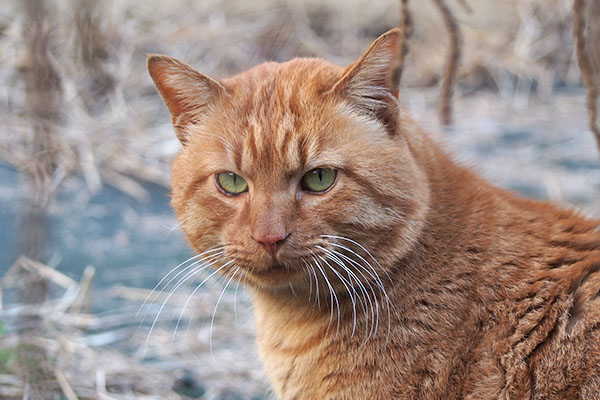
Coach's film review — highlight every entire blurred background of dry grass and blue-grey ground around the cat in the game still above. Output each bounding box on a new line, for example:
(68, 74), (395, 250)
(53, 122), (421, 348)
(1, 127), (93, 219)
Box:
(0, 0), (600, 400)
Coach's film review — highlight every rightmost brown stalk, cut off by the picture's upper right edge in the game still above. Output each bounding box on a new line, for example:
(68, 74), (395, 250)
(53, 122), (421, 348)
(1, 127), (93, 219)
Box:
(573, 0), (600, 152)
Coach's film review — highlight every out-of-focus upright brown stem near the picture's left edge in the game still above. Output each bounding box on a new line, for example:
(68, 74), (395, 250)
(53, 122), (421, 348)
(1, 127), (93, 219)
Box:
(20, 0), (61, 303)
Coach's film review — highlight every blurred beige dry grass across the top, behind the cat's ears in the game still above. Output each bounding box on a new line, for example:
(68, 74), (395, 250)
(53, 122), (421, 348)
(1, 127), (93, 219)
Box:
(0, 0), (592, 199)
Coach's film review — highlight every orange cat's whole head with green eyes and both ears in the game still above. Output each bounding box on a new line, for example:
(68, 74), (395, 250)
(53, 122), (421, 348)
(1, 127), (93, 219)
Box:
(148, 30), (428, 290)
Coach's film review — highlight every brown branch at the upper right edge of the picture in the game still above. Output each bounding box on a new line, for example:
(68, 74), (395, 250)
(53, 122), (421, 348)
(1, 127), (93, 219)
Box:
(573, 0), (600, 155)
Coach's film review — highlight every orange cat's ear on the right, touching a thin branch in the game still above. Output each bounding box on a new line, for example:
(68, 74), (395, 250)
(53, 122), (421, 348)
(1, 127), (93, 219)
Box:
(331, 28), (402, 134)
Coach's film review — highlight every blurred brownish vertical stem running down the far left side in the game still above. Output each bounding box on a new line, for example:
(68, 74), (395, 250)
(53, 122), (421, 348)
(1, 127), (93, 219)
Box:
(17, 0), (62, 392)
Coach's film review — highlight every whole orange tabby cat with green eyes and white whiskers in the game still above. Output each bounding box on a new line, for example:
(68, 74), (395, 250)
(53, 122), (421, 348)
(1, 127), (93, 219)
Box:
(148, 30), (600, 399)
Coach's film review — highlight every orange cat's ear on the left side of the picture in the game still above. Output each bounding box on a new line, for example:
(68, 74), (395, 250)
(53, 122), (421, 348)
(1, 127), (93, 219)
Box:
(147, 54), (226, 145)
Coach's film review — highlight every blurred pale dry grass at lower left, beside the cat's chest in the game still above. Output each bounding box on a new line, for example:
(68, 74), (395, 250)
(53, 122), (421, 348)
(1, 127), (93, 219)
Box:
(0, 257), (268, 399)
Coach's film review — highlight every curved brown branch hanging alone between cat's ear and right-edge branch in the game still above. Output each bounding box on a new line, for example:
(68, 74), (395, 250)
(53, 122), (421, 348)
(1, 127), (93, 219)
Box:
(433, 0), (462, 125)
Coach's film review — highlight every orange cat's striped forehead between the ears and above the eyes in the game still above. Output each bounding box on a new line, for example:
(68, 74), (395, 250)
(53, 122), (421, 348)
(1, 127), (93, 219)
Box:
(206, 59), (340, 179)
